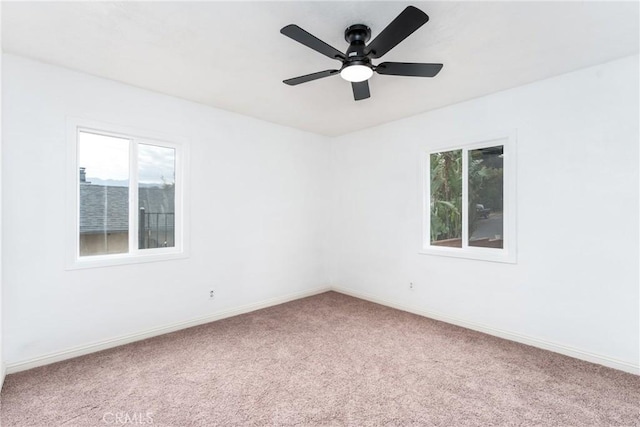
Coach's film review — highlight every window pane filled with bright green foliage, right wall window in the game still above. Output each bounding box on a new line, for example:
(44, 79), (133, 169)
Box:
(429, 150), (462, 248)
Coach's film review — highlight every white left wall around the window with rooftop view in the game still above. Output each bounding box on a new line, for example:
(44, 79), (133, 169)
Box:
(2, 55), (329, 365)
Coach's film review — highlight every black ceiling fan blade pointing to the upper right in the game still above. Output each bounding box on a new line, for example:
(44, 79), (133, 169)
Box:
(365, 6), (429, 58)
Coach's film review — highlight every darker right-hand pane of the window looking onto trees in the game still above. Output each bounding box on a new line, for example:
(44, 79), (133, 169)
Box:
(468, 145), (504, 249)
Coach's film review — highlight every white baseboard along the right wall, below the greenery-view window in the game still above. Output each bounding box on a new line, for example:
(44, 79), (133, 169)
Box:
(331, 286), (640, 375)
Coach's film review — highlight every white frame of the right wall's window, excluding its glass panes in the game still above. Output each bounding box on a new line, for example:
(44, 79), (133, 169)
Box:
(419, 130), (517, 264)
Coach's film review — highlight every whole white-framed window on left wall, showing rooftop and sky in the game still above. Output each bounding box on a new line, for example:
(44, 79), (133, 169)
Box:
(70, 118), (185, 268)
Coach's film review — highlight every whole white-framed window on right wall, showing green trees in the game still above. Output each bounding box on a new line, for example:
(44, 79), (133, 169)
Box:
(421, 135), (515, 262)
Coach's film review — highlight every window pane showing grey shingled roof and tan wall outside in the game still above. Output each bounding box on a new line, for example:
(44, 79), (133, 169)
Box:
(78, 131), (129, 256)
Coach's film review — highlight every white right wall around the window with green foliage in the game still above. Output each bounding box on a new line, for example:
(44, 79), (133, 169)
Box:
(330, 56), (640, 372)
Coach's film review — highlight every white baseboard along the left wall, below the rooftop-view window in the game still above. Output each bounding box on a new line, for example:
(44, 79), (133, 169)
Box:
(2, 287), (331, 374)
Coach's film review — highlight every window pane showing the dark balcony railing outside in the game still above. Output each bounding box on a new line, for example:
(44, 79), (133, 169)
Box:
(138, 144), (176, 249)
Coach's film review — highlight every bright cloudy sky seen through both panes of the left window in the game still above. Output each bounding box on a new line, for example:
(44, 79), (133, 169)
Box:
(78, 132), (175, 186)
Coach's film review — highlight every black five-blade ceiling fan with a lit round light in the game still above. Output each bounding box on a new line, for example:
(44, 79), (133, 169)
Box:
(280, 6), (442, 101)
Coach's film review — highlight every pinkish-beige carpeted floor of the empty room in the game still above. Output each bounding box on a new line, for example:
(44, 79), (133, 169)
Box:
(0, 292), (640, 427)
